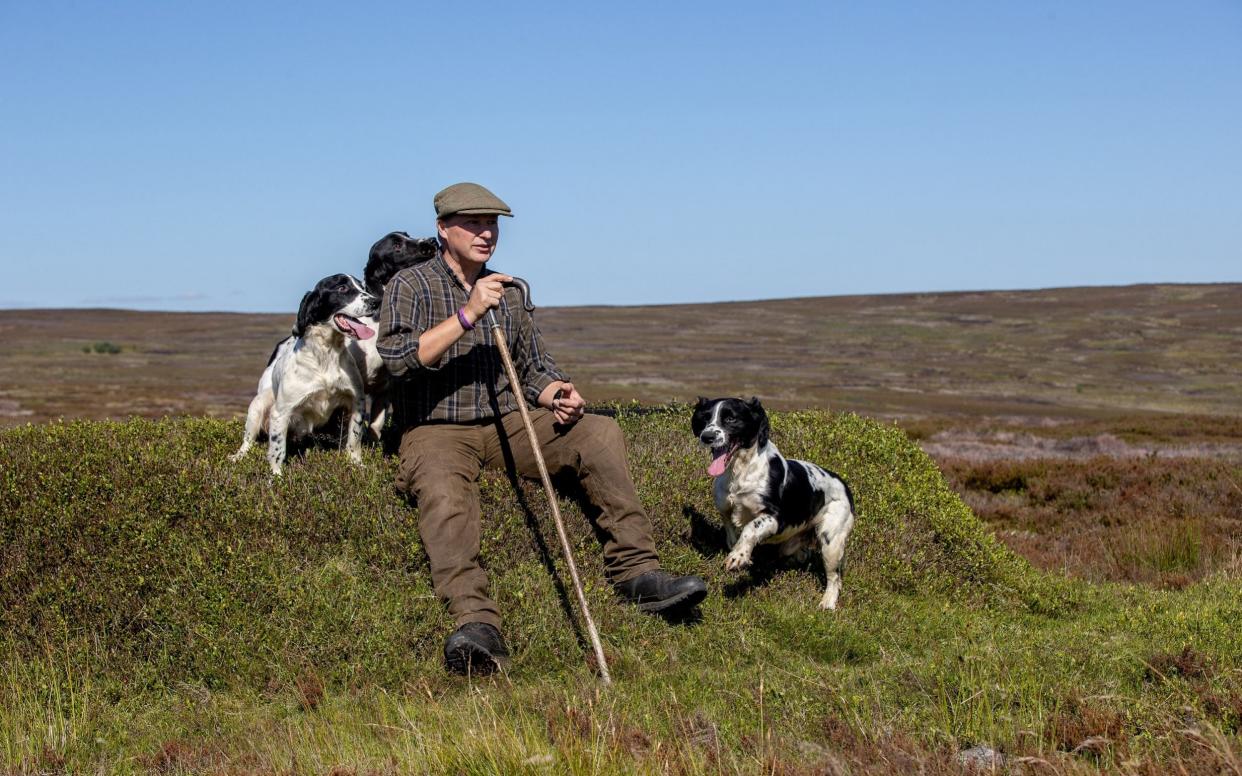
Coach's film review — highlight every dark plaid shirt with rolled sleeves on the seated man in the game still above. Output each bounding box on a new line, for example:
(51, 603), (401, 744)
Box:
(376, 256), (569, 428)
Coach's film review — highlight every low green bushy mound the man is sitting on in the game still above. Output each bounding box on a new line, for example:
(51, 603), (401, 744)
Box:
(0, 408), (1056, 685)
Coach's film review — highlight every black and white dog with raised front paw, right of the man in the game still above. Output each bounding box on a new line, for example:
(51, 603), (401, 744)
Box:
(691, 399), (854, 608)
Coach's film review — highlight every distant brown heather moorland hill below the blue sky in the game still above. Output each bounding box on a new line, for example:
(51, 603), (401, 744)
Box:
(0, 283), (1242, 426)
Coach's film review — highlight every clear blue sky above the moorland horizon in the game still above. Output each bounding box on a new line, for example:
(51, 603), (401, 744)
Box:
(0, 0), (1242, 312)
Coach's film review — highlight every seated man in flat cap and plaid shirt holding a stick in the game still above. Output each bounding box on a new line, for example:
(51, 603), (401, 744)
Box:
(378, 183), (707, 673)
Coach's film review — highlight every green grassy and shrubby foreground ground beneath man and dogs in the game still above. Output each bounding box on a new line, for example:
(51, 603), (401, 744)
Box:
(0, 408), (1242, 774)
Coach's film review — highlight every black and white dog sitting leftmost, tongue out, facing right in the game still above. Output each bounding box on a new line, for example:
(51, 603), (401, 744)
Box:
(232, 274), (378, 474)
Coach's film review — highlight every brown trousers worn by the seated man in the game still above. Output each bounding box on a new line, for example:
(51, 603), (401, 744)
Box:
(396, 408), (660, 628)
